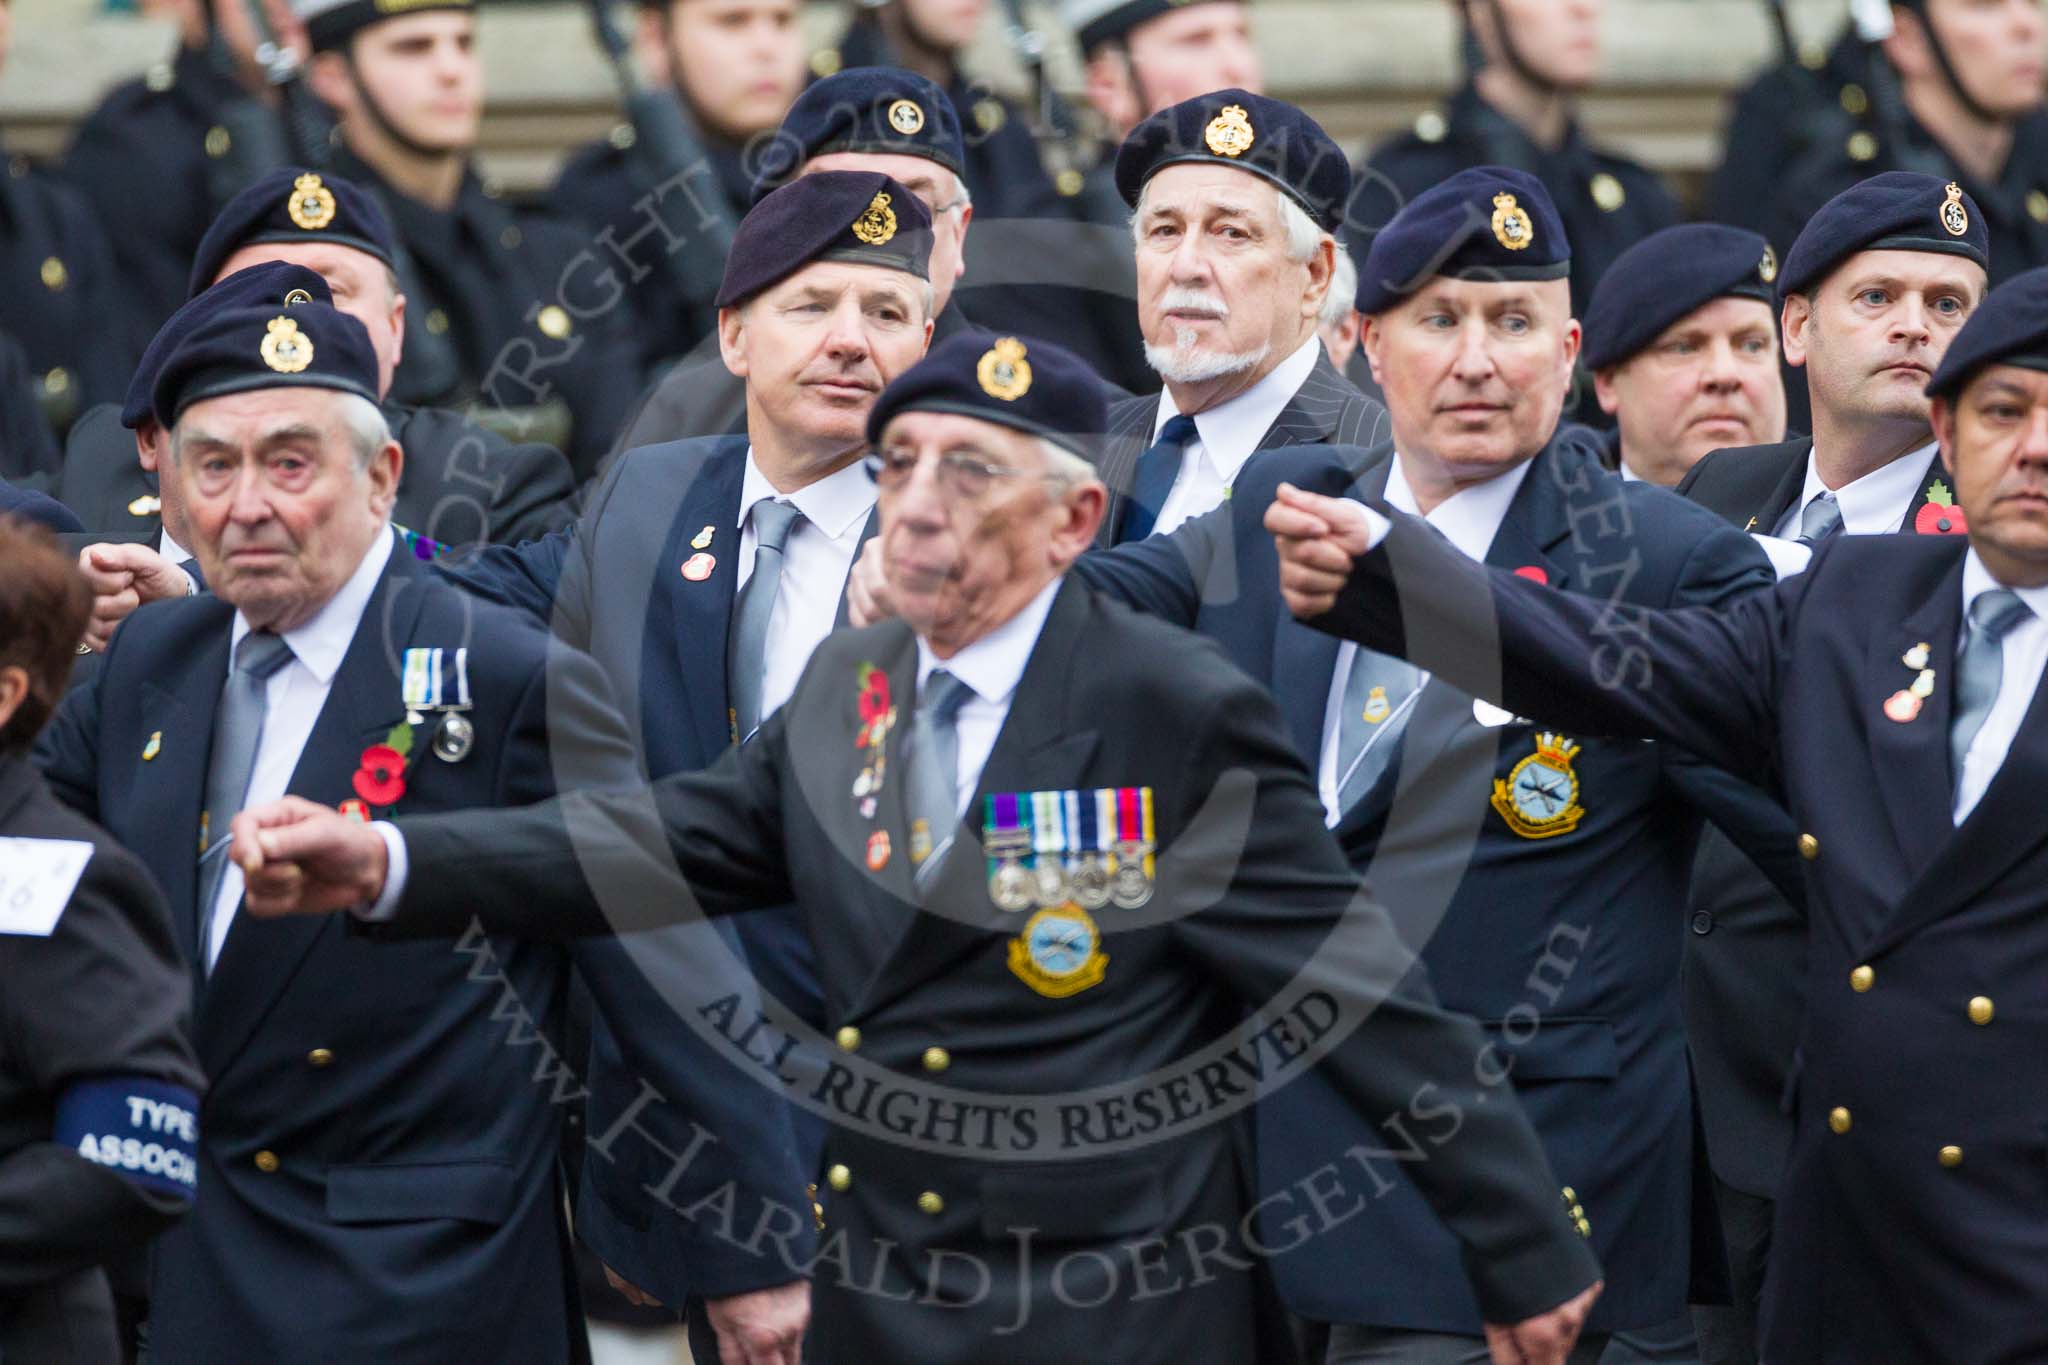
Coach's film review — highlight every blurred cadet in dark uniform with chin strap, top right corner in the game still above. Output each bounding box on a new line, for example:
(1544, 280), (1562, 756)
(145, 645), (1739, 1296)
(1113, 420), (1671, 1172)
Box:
(1761, 0), (2048, 284)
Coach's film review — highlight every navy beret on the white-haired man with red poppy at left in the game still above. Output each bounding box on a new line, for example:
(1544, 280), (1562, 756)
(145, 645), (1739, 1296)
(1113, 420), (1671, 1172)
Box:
(150, 303), (377, 428)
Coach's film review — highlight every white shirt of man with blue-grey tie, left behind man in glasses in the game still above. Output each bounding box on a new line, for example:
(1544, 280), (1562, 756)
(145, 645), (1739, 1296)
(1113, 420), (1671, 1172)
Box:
(733, 446), (874, 720)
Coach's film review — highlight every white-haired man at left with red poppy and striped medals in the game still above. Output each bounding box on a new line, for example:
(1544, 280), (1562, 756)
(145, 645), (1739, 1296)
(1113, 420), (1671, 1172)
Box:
(37, 290), (663, 1365)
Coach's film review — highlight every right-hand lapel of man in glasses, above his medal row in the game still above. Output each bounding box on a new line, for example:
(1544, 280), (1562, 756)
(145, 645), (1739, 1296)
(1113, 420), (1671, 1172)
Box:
(860, 583), (1100, 1009)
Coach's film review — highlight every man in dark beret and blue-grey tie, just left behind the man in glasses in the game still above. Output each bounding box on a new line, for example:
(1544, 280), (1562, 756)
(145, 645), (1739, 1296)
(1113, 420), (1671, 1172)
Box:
(419, 170), (934, 1359)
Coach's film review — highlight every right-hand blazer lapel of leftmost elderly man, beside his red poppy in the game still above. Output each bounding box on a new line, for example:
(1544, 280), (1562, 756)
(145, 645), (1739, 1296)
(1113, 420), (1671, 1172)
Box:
(199, 551), (426, 1074)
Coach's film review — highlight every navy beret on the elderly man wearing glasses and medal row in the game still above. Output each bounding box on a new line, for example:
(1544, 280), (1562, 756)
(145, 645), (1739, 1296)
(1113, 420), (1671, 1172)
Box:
(868, 329), (1110, 465)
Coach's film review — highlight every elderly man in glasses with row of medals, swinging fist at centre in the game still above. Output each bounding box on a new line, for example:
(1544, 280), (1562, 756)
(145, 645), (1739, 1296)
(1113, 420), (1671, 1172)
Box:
(224, 336), (1597, 1365)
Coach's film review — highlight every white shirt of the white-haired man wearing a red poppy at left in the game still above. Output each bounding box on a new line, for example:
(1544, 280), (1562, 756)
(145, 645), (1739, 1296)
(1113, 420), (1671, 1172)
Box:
(205, 530), (397, 972)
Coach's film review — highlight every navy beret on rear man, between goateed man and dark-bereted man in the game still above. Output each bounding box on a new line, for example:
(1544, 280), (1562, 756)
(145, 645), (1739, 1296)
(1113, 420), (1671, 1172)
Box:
(752, 65), (967, 203)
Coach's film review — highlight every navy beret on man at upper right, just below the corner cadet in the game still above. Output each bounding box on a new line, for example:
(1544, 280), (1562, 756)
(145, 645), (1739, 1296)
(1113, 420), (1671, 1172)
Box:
(1778, 170), (1991, 297)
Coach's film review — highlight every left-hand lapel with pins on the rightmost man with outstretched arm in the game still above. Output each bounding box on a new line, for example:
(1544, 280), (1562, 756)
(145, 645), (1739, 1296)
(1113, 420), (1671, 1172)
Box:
(1858, 559), (1962, 892)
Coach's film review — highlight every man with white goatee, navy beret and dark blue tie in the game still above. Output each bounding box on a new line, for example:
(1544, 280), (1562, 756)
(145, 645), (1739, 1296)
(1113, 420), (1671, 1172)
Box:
(1100, 90), (1386, 544)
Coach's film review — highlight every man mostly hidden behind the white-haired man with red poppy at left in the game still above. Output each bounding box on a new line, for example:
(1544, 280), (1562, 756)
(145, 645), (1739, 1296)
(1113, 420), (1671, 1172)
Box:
(57, 168), (573, 544)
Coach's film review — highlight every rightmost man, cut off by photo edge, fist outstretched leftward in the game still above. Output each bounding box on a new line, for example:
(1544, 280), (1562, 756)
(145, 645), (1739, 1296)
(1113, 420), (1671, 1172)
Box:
(1268, 270), (2048, 1365)
